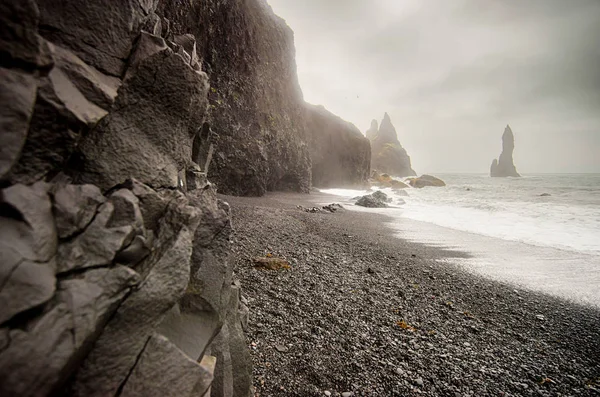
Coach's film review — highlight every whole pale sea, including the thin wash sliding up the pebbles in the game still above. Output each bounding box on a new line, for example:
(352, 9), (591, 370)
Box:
(323, 174), (600, 307)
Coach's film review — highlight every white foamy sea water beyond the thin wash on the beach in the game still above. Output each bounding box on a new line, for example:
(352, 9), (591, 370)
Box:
(324, 175), (600, 255)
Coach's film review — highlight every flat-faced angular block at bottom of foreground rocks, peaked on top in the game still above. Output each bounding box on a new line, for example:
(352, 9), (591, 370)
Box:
(120, 334), (212, 397)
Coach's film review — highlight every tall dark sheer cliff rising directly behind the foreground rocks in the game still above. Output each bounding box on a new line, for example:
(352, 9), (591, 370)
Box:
(158, 0), (311, 196)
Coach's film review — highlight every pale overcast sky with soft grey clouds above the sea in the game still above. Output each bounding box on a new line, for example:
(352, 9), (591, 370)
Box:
(268, 0), (600, 173)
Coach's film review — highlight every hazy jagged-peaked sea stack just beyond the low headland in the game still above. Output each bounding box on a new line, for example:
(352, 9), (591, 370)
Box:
(366, 113), (417, 177)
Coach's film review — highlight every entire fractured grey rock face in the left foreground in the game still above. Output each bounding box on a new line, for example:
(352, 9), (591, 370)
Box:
(0, 0), (251, 397)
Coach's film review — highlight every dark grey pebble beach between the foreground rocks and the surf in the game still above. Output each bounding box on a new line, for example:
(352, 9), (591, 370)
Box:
(221, 193), (600, 397)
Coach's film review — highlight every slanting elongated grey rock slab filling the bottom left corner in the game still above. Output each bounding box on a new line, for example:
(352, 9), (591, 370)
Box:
(0, 266), (138, 397)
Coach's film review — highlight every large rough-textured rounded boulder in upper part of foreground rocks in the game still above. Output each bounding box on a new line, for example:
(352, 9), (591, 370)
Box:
(76, 49), (208, 189)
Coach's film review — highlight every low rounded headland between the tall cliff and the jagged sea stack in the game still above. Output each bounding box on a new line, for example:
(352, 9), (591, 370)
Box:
(306, 104), (371, 187)
